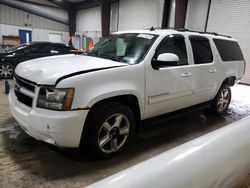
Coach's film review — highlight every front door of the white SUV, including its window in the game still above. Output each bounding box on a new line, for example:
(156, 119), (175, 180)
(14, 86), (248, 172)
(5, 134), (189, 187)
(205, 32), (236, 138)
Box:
(145, 34), (193, 118)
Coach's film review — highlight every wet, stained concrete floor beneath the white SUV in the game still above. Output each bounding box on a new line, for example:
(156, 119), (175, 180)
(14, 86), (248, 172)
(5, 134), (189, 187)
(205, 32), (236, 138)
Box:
(0, 81), (250, 188)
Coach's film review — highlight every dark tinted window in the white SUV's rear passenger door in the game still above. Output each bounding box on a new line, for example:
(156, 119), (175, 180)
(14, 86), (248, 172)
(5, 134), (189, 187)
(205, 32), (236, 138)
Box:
(189, 36), (213, 64)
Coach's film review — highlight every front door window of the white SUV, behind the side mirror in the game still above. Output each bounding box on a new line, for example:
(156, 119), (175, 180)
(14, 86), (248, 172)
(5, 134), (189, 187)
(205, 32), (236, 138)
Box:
(155, 35), (188, 65)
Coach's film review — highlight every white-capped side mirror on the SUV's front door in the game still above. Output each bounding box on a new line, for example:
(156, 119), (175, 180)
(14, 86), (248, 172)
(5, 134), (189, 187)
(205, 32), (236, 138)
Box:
(152, 53), (180, 70)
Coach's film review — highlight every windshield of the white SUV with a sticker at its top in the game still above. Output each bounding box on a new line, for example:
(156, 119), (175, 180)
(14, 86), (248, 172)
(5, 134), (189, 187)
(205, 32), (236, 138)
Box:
(86, 33), (157, 64)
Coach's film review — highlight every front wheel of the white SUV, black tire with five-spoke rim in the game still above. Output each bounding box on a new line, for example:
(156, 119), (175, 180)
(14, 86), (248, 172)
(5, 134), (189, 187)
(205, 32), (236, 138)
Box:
(82, 102), (135, 159)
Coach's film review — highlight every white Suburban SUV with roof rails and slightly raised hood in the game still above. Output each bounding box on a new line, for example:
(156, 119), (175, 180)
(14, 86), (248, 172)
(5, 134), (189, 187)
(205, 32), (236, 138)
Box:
(9, 29), (245, 158)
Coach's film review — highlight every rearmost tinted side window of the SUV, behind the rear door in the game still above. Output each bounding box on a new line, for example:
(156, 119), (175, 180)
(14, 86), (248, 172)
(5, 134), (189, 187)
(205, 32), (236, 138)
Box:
(213, 39), (244, 61)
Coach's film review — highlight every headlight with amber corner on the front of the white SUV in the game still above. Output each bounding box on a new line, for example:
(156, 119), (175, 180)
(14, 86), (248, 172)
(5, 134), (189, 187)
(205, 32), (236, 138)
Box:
(36, 87), (74, 110)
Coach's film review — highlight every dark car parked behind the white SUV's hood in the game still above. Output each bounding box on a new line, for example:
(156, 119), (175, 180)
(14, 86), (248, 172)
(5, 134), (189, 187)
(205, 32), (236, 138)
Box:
(0, 42), (75, 79)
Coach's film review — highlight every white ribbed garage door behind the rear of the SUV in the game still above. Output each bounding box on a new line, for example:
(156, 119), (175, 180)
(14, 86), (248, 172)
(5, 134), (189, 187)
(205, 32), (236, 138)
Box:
(207, 0), (250, 84)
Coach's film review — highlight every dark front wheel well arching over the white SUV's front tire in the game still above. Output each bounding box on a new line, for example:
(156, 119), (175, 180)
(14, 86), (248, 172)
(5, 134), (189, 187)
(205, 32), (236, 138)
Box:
(87, 95), (141, 132)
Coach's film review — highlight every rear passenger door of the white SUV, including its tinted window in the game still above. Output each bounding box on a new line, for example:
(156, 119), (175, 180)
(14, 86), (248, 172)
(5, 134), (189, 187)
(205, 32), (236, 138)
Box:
(189, 35), (218, 103)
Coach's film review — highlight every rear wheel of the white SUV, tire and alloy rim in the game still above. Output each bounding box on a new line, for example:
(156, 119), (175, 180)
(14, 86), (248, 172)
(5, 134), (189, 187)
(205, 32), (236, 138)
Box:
(211, 84), (232, 115)
